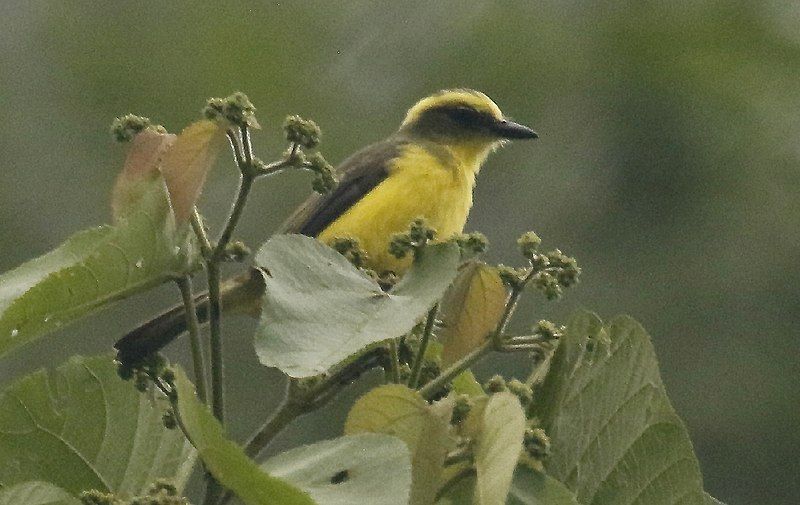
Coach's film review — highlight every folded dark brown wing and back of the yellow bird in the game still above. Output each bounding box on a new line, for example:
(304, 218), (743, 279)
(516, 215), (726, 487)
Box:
(278, 138), (405, 237)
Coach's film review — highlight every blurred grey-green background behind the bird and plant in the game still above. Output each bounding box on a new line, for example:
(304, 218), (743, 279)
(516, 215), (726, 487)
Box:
(0, 0), (800, 505)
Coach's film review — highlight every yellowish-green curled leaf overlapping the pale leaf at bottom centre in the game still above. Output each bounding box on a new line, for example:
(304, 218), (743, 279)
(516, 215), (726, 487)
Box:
(344, 384), (453, 505)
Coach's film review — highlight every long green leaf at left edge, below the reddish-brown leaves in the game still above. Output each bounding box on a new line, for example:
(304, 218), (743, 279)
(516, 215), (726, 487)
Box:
(0, 174), (197, 356)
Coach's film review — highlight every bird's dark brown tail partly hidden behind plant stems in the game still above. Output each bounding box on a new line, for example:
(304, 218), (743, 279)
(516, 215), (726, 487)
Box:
(114, 269), (264, 364)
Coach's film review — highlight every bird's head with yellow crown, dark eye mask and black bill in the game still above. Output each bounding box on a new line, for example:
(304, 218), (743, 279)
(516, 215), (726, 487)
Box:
(400, 89), (537, 149)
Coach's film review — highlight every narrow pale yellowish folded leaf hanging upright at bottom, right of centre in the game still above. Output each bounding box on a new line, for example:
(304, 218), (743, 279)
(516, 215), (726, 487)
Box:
(470, 391), (525, 505)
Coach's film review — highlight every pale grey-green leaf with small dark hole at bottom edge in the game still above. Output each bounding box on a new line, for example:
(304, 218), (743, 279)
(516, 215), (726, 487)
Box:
(261, 433), (411, 505)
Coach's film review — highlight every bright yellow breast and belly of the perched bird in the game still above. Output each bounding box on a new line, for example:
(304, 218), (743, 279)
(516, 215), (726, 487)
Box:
(319, 144), (488, 273)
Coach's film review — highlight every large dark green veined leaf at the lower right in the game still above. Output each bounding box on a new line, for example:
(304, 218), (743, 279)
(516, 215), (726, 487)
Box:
(534, 312), (706, 505)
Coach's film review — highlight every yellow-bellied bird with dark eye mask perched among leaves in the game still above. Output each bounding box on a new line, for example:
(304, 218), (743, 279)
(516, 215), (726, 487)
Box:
(115, 89), (538, 361)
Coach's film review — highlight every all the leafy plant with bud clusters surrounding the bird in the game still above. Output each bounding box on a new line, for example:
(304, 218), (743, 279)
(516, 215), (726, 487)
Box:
(0, 93), (718, 505)
